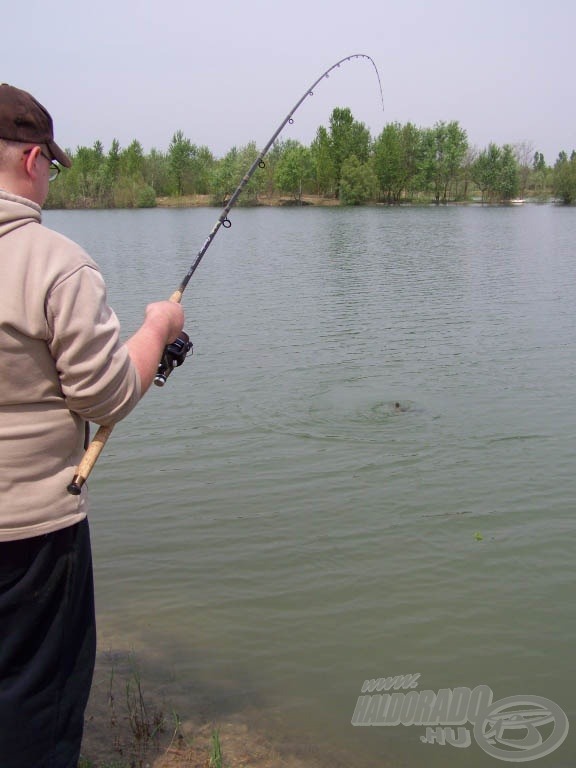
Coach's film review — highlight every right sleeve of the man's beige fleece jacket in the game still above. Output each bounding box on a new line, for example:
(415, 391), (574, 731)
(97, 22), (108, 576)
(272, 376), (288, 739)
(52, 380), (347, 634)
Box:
(45, 264), (141, 425)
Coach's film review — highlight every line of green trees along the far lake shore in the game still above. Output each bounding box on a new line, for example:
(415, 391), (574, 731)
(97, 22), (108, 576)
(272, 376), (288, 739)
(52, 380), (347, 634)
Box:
(47, 107), (576, 208)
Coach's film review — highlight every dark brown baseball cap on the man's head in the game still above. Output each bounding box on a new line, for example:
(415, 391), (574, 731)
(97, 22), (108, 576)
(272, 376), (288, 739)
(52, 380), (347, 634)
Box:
(0, 83), (72, 168)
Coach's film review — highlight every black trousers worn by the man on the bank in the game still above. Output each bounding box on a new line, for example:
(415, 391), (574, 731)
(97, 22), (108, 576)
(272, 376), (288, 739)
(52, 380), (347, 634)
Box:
(0, 520), (96, 768)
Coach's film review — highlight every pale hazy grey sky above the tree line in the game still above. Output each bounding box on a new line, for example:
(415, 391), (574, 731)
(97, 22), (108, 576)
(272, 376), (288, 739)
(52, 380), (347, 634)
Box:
(5, 0), (576, 164)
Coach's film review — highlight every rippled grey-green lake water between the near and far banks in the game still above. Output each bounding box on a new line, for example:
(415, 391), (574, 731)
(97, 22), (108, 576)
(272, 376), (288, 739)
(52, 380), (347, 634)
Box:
(45, 205), (576, 768)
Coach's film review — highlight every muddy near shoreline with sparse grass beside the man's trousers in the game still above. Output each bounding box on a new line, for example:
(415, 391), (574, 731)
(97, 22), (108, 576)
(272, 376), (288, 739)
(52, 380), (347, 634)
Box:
(79, 650), (372, 768)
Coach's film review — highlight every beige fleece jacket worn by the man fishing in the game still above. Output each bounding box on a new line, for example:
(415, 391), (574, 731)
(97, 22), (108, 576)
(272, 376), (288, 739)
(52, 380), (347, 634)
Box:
(0, 190), (140, 541)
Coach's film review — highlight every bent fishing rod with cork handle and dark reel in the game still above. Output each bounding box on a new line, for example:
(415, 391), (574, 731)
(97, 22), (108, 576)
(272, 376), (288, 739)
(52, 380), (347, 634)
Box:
(67, 53), (384, 496)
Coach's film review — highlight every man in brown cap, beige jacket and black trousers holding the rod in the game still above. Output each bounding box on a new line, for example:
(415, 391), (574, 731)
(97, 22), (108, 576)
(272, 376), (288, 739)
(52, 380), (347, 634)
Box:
(0, 84), (184, 768)
